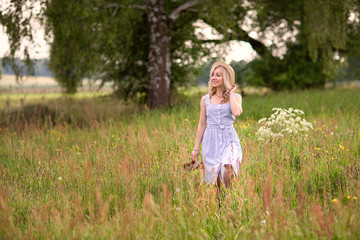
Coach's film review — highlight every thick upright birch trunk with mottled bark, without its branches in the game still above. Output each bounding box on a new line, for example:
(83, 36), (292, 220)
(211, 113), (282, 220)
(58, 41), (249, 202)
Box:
(147, 0), (171, 108)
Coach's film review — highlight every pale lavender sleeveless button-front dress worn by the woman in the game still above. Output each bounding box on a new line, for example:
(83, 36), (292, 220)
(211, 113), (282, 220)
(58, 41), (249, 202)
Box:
(202, 94), (242, 184)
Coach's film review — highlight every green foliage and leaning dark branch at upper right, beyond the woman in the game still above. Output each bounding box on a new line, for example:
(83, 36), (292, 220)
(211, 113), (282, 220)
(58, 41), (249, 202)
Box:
(211, 0), (360, 90)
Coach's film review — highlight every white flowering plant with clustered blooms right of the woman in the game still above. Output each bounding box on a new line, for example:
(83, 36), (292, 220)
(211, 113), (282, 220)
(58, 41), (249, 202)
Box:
(256, 108), (313, 141)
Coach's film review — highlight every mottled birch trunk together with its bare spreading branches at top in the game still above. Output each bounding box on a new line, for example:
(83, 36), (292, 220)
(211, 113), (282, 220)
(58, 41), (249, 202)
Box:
(102, 0), (205, 108)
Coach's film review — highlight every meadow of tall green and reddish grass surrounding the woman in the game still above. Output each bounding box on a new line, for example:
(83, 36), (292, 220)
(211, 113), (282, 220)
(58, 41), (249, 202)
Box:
(0, 89), (360, 239)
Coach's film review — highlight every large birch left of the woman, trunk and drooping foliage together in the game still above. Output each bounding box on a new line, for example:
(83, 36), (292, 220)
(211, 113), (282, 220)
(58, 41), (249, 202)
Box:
(1, 0), (209, 108)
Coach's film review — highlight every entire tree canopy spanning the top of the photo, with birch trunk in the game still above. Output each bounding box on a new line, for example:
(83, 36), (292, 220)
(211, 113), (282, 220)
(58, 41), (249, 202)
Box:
(0, 0), (360, 103)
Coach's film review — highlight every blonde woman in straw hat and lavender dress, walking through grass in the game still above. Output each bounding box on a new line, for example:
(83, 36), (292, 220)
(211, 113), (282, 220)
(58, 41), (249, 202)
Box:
(191, 62), (242, 187)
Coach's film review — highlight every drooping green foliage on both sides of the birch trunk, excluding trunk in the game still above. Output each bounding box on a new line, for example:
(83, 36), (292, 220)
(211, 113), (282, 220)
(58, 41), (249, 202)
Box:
(45, 0), (207, 101)
